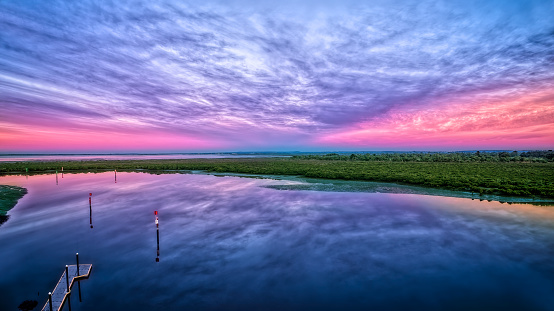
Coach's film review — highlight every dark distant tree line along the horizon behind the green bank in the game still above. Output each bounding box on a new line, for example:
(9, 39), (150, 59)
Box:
(292, 150), (554, 163)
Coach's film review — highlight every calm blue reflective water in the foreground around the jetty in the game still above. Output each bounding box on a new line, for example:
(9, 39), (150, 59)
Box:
(0, 173), (554, 310)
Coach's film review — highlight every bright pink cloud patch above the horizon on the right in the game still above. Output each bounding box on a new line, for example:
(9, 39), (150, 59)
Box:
(316, 91), (554, 150)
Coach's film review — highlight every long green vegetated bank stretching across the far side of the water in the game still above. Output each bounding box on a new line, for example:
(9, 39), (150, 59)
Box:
(0, 158), (554, 198)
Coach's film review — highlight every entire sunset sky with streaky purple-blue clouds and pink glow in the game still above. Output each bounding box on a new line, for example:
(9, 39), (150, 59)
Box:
(0, 0), (554, 153)
